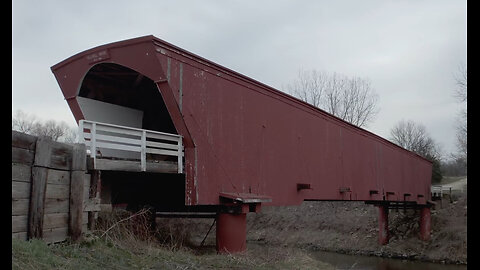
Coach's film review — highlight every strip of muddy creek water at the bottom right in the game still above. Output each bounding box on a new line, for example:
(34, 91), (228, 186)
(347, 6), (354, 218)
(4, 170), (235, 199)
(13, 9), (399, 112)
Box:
(310, 251), (467, 270)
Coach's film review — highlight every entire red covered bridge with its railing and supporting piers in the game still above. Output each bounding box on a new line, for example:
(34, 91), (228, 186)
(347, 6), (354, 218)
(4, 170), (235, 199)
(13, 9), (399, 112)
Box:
(51, 36), (432, 252)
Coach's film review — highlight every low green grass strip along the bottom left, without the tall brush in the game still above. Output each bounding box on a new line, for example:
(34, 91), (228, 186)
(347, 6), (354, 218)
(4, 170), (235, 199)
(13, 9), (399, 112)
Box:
(12, 239), (333, 270)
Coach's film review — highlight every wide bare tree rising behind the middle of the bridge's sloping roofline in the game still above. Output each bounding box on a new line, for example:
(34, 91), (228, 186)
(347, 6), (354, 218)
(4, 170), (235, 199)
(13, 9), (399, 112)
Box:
(286, 70), (378, 127)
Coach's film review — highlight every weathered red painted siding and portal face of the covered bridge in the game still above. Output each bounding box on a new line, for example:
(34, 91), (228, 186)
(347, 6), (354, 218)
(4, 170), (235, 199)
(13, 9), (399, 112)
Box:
(52, 36), (432, 208)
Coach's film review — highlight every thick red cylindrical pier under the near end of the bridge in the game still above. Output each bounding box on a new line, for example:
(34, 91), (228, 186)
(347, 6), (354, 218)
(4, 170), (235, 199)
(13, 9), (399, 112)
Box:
(216, 213), (247, 253)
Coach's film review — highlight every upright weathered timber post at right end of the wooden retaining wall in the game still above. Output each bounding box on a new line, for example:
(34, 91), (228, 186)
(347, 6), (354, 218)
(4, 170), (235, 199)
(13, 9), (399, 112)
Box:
(69, 171), (85, 241)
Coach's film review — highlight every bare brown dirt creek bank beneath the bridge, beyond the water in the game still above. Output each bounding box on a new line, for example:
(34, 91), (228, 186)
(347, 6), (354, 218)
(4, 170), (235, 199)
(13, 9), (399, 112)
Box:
(167, 191), (467, 264)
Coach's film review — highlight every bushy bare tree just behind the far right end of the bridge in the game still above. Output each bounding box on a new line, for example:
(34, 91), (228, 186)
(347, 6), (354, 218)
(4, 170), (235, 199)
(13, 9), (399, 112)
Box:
(390, 120), (442, 183)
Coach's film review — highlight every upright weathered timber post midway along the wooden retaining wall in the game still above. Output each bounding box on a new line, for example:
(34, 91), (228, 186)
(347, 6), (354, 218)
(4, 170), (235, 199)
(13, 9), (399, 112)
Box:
(28, 168), (48, 239)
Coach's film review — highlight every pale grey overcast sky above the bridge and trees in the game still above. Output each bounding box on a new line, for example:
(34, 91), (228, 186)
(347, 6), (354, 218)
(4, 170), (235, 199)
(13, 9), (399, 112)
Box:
(12, 0), (467, 158)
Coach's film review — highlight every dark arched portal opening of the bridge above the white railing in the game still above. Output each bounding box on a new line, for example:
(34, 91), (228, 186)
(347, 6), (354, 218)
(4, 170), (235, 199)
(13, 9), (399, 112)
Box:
(77, 63), (178, 134)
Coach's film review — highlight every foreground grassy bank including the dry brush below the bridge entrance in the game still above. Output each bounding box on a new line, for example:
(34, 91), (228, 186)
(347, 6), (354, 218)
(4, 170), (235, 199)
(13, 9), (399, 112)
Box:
(12, 211), (334, 270)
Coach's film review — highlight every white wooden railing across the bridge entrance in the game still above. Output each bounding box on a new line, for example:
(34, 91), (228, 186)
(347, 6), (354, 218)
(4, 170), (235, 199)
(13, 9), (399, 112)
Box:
(78, 120), (184, 173)
